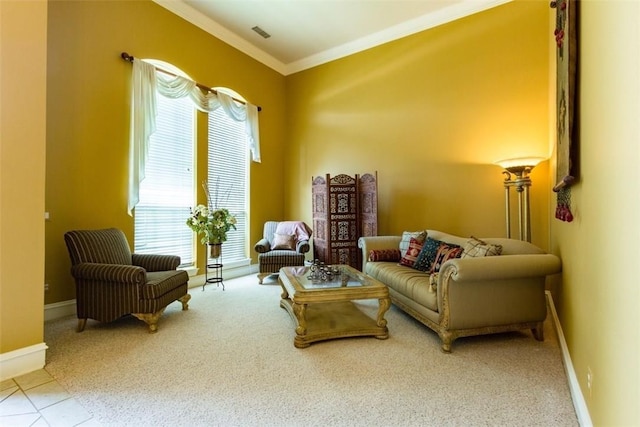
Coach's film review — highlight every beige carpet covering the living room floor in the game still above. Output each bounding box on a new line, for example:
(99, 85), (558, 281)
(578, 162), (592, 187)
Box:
(45, 276), (578, 426)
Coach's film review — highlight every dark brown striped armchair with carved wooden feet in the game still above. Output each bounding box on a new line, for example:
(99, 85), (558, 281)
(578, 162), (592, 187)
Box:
(64, 228), (191, 332)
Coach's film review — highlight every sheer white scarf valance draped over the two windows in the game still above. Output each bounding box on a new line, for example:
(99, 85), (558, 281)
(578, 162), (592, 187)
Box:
(127, 59), (260, 215)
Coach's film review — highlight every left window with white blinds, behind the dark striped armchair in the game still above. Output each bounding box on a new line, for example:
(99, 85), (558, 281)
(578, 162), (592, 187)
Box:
(134, 94), (195, 267)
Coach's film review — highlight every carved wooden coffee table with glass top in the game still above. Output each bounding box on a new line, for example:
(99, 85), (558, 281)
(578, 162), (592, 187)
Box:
(278, 265), (391, 348)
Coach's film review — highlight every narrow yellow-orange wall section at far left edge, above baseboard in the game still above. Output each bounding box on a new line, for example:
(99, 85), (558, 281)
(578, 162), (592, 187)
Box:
(0, 1), (47, 354)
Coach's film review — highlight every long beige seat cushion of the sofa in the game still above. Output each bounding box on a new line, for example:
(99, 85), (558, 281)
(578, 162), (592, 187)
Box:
(365, 262), (438, 312)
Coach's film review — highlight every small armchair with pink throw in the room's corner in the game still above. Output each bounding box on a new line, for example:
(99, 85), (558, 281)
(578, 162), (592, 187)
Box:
(254, 221), (311, 284)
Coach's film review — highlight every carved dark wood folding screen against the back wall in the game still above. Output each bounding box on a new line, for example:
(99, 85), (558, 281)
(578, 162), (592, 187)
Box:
(312, 174), (378, 269)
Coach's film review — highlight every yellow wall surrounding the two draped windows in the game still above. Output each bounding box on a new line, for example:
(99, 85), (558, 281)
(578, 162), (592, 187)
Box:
(46, 1), (285, 303)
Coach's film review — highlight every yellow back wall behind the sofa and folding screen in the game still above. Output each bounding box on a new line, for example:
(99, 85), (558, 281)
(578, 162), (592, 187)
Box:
(285, 2), (550, 249)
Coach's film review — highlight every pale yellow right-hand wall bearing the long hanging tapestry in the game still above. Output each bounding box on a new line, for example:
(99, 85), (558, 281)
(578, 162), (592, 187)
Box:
(551, 1), (640, 426)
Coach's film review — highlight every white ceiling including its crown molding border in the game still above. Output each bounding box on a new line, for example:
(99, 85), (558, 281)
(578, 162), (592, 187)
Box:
(154, 0), (511, 75)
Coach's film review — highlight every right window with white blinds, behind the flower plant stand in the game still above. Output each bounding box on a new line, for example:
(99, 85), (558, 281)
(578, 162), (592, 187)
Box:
(207, 92), (249, 266)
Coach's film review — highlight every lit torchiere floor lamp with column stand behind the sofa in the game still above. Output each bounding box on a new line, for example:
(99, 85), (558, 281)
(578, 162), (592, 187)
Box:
(496, 157), (545, 242)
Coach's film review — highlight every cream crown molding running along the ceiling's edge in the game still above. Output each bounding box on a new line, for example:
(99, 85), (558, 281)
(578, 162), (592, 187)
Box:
(153, 0), (513, 76)
